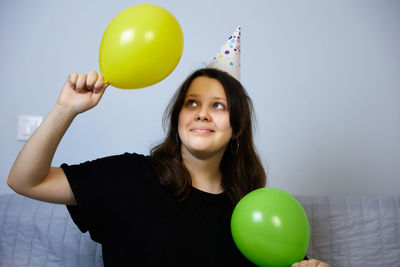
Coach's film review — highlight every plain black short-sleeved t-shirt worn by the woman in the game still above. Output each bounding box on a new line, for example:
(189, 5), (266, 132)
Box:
(61, 153), (255, 267)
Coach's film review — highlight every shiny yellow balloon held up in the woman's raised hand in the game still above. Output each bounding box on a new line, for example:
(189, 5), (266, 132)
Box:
(99, 4), (183, 89)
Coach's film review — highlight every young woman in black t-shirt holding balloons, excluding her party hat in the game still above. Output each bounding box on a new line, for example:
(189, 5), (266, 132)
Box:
(8, 68), (327, 267)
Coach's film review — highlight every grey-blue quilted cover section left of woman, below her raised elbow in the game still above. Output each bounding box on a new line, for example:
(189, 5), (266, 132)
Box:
(0, 194), (103, 267)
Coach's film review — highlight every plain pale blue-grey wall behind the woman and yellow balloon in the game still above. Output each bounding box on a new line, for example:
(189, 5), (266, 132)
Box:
(0, 0), (400, 195)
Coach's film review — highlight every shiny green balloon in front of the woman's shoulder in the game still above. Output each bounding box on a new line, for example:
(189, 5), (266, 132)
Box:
(231, 188), (310, 267)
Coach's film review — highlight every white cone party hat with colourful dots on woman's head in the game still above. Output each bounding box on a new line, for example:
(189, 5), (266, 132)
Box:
(208, 26), (240, 81)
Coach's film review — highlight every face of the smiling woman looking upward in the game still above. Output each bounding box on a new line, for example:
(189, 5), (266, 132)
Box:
(178, 76), (232, 158)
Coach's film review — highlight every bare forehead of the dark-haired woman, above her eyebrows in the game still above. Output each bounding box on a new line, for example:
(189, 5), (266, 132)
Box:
(186, 76), (226, 99)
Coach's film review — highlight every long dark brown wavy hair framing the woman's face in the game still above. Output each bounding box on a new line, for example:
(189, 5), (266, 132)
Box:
(150, 68), (266, 204)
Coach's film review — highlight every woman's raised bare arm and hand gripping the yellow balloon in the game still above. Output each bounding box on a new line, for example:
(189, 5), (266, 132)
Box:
(7, 71), (108, 205)
